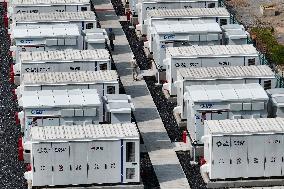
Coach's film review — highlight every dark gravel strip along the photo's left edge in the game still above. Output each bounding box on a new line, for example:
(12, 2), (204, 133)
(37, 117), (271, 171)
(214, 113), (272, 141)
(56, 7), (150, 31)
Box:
(0, 6), (27, 189)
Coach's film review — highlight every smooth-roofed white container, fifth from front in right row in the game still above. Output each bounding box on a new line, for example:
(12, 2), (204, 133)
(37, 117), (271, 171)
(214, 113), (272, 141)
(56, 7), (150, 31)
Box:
(147, 19), (222, 70)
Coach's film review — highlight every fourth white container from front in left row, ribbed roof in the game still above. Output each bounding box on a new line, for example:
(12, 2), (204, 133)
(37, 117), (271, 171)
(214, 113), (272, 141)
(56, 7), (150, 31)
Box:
(14, 49), (111, 84)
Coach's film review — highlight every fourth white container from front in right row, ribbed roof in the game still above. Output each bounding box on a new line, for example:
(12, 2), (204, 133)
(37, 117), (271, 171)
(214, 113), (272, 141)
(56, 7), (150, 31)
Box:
(164, 45), (260, 94)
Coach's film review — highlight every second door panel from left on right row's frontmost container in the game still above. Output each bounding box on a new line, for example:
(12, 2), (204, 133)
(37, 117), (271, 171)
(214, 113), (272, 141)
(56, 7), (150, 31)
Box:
(230, 135), (248, 178)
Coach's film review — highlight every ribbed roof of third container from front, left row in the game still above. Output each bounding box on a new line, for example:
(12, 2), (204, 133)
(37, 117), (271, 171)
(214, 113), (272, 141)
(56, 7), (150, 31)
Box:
(22, 70), (118, 86)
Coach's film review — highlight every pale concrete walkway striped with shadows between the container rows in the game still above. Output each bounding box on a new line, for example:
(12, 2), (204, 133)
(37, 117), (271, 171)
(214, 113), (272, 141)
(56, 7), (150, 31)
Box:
(93, 0), (190, 189)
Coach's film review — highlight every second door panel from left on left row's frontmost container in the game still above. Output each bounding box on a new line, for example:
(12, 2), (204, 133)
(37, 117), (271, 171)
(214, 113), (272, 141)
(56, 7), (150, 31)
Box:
(52, 142), (69, 185)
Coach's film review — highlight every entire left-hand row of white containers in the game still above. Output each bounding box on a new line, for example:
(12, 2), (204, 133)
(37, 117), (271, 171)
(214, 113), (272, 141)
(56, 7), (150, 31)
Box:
(3, 0), (140, 188)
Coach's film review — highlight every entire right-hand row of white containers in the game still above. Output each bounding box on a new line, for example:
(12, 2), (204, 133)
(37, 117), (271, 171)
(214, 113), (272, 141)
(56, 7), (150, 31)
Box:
(124, 0), (284, 185)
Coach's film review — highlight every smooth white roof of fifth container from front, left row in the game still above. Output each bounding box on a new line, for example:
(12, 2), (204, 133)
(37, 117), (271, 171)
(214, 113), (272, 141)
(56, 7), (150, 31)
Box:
(12, 24), (80, 39)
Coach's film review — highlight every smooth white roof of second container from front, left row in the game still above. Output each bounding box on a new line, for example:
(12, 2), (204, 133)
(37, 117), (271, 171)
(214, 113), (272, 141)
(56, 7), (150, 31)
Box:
(19, 89), (101, 108)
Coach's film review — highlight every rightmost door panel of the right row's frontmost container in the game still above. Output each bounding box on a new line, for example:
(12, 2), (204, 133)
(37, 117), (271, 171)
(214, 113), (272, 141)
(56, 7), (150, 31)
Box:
(264, 135), (283, 177)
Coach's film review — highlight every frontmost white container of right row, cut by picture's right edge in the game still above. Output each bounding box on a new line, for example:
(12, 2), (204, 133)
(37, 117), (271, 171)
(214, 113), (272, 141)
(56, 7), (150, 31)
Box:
(201, 118), (284, 180)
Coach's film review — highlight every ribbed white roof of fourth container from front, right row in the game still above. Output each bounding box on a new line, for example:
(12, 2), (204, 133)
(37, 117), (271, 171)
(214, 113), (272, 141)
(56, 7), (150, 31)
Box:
(166, 45), (258, 58)
